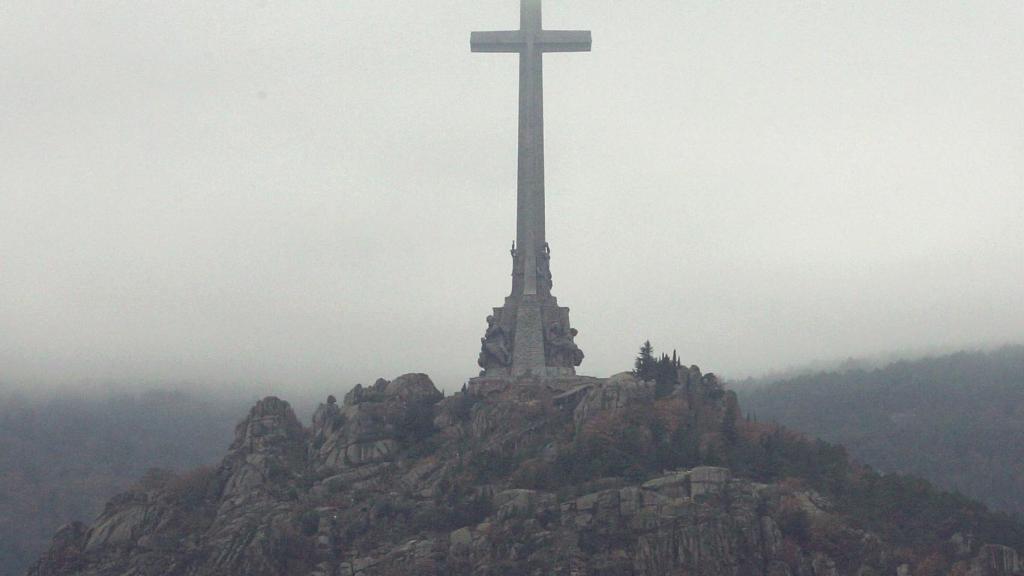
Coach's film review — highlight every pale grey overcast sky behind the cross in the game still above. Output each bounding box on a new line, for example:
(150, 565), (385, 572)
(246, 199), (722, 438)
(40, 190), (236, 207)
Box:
(0, 0), (1024, 393)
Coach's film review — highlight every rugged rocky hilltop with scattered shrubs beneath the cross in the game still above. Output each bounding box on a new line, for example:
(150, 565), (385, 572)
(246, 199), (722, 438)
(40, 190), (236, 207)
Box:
(29, 367), (1024, 576)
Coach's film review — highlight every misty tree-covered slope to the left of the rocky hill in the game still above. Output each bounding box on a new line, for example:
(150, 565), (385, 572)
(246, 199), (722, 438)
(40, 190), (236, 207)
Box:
(0, 392), (244, 576)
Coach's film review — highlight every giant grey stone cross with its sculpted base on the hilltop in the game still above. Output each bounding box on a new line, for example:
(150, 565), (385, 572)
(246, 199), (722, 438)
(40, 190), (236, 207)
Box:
(470, 0), (591, 378)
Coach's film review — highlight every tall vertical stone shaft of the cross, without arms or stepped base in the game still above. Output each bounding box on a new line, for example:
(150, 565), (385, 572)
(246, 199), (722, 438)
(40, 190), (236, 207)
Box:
(520, 0), (545, 295)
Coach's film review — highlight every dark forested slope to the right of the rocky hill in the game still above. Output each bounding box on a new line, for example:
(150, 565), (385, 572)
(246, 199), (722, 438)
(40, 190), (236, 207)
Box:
(740, 346), (1024, 513)
